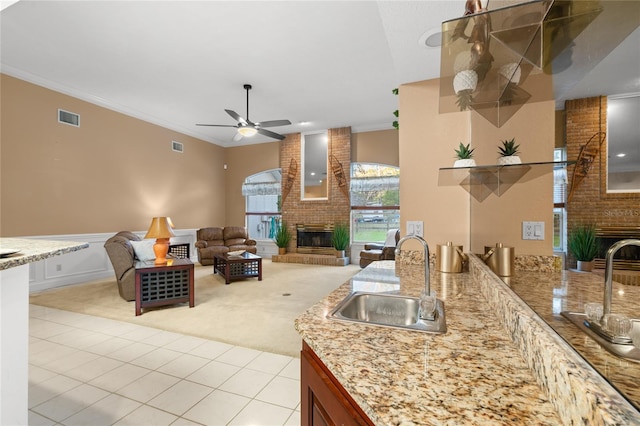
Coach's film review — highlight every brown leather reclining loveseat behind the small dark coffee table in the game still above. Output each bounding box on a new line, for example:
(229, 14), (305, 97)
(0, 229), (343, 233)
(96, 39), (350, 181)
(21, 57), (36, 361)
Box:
(195, 226), (258, 265)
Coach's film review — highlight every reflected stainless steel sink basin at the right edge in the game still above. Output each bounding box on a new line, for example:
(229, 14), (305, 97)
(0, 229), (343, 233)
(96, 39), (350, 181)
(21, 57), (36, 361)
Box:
(560, 311), (640, 362)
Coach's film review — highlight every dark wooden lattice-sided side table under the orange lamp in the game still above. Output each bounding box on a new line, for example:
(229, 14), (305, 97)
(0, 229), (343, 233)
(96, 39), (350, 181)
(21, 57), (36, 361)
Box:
(136, 259), (194, 316)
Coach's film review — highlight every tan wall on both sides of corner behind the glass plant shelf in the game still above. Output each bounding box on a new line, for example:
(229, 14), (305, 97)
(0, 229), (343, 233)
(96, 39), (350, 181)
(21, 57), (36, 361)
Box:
(400, 80), (555, 255)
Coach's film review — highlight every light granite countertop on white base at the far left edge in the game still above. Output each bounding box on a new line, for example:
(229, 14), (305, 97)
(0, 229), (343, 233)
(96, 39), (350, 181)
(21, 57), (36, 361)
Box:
(0, 238), (89, 270)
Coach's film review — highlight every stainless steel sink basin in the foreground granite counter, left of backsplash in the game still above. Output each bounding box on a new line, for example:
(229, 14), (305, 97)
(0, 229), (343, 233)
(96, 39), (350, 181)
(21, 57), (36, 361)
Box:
(327, 292), (447, 333)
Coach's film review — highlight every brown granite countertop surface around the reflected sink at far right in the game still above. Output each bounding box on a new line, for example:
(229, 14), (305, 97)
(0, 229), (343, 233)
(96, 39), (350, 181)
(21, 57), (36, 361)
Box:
(504, 271), (640, 412)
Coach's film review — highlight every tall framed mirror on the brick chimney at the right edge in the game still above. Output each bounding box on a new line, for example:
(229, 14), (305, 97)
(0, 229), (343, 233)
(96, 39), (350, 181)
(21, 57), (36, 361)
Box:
(606, 93), (640, 193)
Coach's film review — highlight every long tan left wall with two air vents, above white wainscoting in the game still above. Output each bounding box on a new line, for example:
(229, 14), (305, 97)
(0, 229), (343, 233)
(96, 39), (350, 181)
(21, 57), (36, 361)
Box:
(0, 75), (226, 237)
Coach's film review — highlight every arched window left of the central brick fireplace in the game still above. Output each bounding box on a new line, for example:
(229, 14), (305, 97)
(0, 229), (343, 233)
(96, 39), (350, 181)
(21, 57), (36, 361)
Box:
(242, 169), (282, 240)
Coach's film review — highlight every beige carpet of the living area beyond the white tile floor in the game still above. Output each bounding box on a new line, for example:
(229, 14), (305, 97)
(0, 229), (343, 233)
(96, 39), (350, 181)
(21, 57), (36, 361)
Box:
(30, 259), (360, 357)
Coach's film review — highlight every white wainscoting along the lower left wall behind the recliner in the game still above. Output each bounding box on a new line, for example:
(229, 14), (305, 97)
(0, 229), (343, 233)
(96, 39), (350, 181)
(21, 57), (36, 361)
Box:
(20, 229), (198, 292)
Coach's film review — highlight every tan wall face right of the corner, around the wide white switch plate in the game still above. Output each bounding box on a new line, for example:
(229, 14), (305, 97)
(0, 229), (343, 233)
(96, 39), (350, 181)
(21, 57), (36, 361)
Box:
(471, 101), (555, 256)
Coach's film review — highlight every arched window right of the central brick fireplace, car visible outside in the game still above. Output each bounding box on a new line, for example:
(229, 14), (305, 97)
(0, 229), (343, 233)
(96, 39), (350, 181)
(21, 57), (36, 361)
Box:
(351, 163), (400, 243)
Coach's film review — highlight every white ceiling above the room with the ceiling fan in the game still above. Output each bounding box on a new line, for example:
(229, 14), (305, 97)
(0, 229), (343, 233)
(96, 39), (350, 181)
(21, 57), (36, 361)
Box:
(0, 0), (640, 147)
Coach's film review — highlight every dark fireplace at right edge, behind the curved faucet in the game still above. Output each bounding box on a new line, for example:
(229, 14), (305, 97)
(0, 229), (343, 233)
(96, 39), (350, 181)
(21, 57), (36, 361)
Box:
(594, 226), (640, 271)
